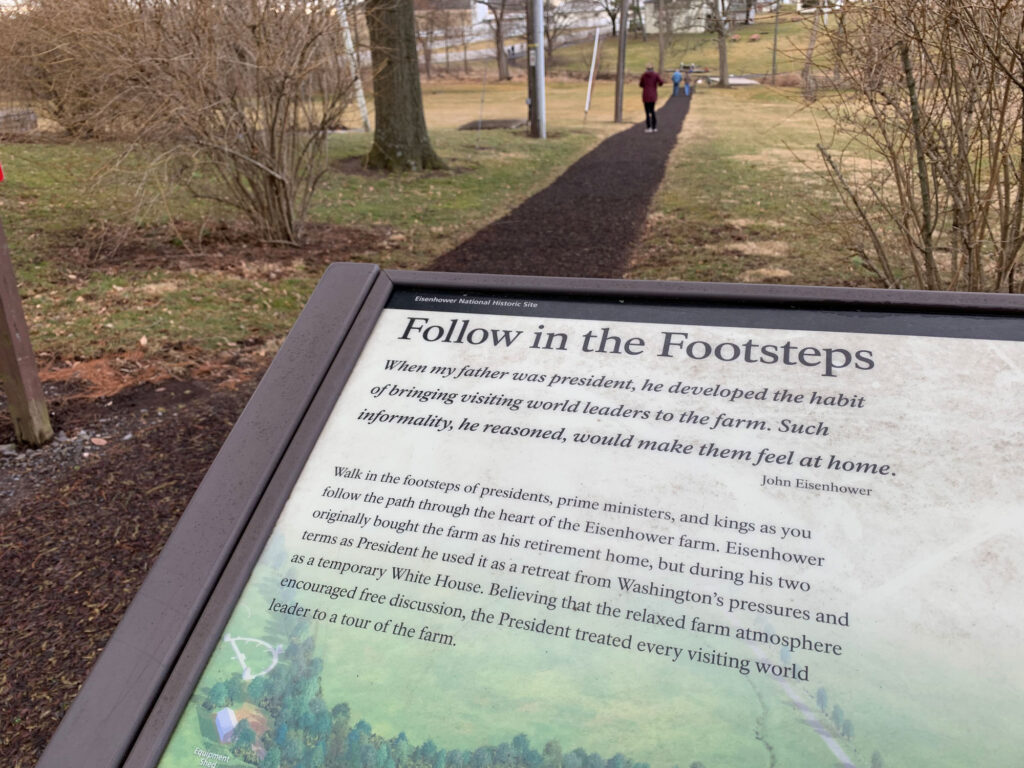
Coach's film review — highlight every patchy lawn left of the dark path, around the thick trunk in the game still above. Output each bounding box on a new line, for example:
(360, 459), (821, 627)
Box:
(0, 81), (642, 360)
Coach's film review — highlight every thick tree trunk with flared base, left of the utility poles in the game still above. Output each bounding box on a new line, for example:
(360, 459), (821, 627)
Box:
(366, 0), (445, 171)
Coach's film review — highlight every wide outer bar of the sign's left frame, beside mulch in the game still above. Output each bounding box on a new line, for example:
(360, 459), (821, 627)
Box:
(37, 264), (380, 768)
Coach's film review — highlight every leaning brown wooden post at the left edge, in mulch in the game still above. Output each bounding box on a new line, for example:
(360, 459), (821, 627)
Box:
(0, 215), (53, 447)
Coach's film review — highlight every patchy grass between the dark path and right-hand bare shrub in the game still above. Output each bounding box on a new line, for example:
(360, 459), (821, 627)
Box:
(629, 86), (871, 286)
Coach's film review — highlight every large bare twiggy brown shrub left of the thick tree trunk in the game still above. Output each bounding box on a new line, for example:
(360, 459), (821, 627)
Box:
(0, 0), (352, 244)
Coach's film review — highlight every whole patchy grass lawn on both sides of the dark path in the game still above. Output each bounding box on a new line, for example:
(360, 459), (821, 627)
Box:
(0, 19), (847, 372)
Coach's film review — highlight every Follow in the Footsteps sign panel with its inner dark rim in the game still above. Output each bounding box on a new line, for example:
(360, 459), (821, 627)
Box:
(39, 264), (1024, 768)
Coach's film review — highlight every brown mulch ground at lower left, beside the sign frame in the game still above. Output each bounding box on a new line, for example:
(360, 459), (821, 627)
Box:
(0, 365), (258, 768)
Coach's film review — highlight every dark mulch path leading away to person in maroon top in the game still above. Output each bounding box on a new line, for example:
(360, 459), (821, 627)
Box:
(430, 94), (690, 278)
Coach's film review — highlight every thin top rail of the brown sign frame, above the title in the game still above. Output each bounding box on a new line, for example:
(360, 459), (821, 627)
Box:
(385, 269), (1024, 315)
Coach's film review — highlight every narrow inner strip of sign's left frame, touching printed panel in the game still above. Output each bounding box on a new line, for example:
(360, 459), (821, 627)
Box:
(123, 273), (392, 768)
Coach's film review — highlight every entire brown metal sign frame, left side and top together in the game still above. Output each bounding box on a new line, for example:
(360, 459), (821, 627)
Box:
(38, 264), (1024, 768)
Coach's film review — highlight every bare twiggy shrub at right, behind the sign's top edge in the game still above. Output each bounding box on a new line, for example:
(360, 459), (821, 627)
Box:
(821, 0), (1024, 292)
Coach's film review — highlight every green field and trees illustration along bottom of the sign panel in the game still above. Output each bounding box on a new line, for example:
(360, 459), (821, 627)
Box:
(153, 536), (1024, 768)
